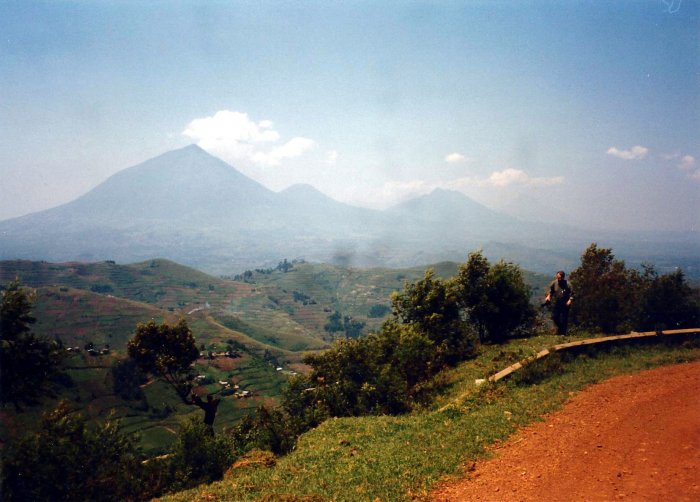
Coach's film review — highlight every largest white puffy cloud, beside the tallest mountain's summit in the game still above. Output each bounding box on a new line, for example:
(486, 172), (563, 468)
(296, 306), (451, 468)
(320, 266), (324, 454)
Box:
(182, 110), (316, 166)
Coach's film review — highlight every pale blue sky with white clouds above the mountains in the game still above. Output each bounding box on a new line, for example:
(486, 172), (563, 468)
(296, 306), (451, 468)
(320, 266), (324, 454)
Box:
(0, 0), (700, 231)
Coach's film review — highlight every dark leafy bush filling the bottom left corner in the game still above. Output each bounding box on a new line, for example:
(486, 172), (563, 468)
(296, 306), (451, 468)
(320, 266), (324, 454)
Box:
(1, 401), (150, 502)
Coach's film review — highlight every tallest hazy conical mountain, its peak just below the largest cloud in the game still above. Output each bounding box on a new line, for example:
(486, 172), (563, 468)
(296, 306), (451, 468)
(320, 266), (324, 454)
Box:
(49, 145), (275, 227)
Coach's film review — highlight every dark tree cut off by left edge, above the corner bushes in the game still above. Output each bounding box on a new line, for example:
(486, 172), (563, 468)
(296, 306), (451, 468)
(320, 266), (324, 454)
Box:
(0, 280), (65, 409)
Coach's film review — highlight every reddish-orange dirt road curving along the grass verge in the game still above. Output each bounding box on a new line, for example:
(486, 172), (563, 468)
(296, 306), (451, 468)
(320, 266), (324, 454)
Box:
(432, 362), (700, 502)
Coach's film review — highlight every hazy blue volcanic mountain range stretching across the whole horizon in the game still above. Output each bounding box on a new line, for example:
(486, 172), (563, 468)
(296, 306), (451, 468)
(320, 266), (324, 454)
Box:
(0, 145), (700, 275)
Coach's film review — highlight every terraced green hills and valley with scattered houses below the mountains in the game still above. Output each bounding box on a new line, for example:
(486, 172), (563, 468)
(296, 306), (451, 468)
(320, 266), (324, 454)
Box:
(0, 255), (548, 453)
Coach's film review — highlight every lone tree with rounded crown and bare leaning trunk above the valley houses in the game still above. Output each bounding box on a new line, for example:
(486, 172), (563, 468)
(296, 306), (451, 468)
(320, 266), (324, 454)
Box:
(127, 319), (219, 430)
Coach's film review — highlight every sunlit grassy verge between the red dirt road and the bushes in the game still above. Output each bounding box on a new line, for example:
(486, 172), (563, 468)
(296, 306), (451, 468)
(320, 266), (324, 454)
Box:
(159, 337), (700, 501)
